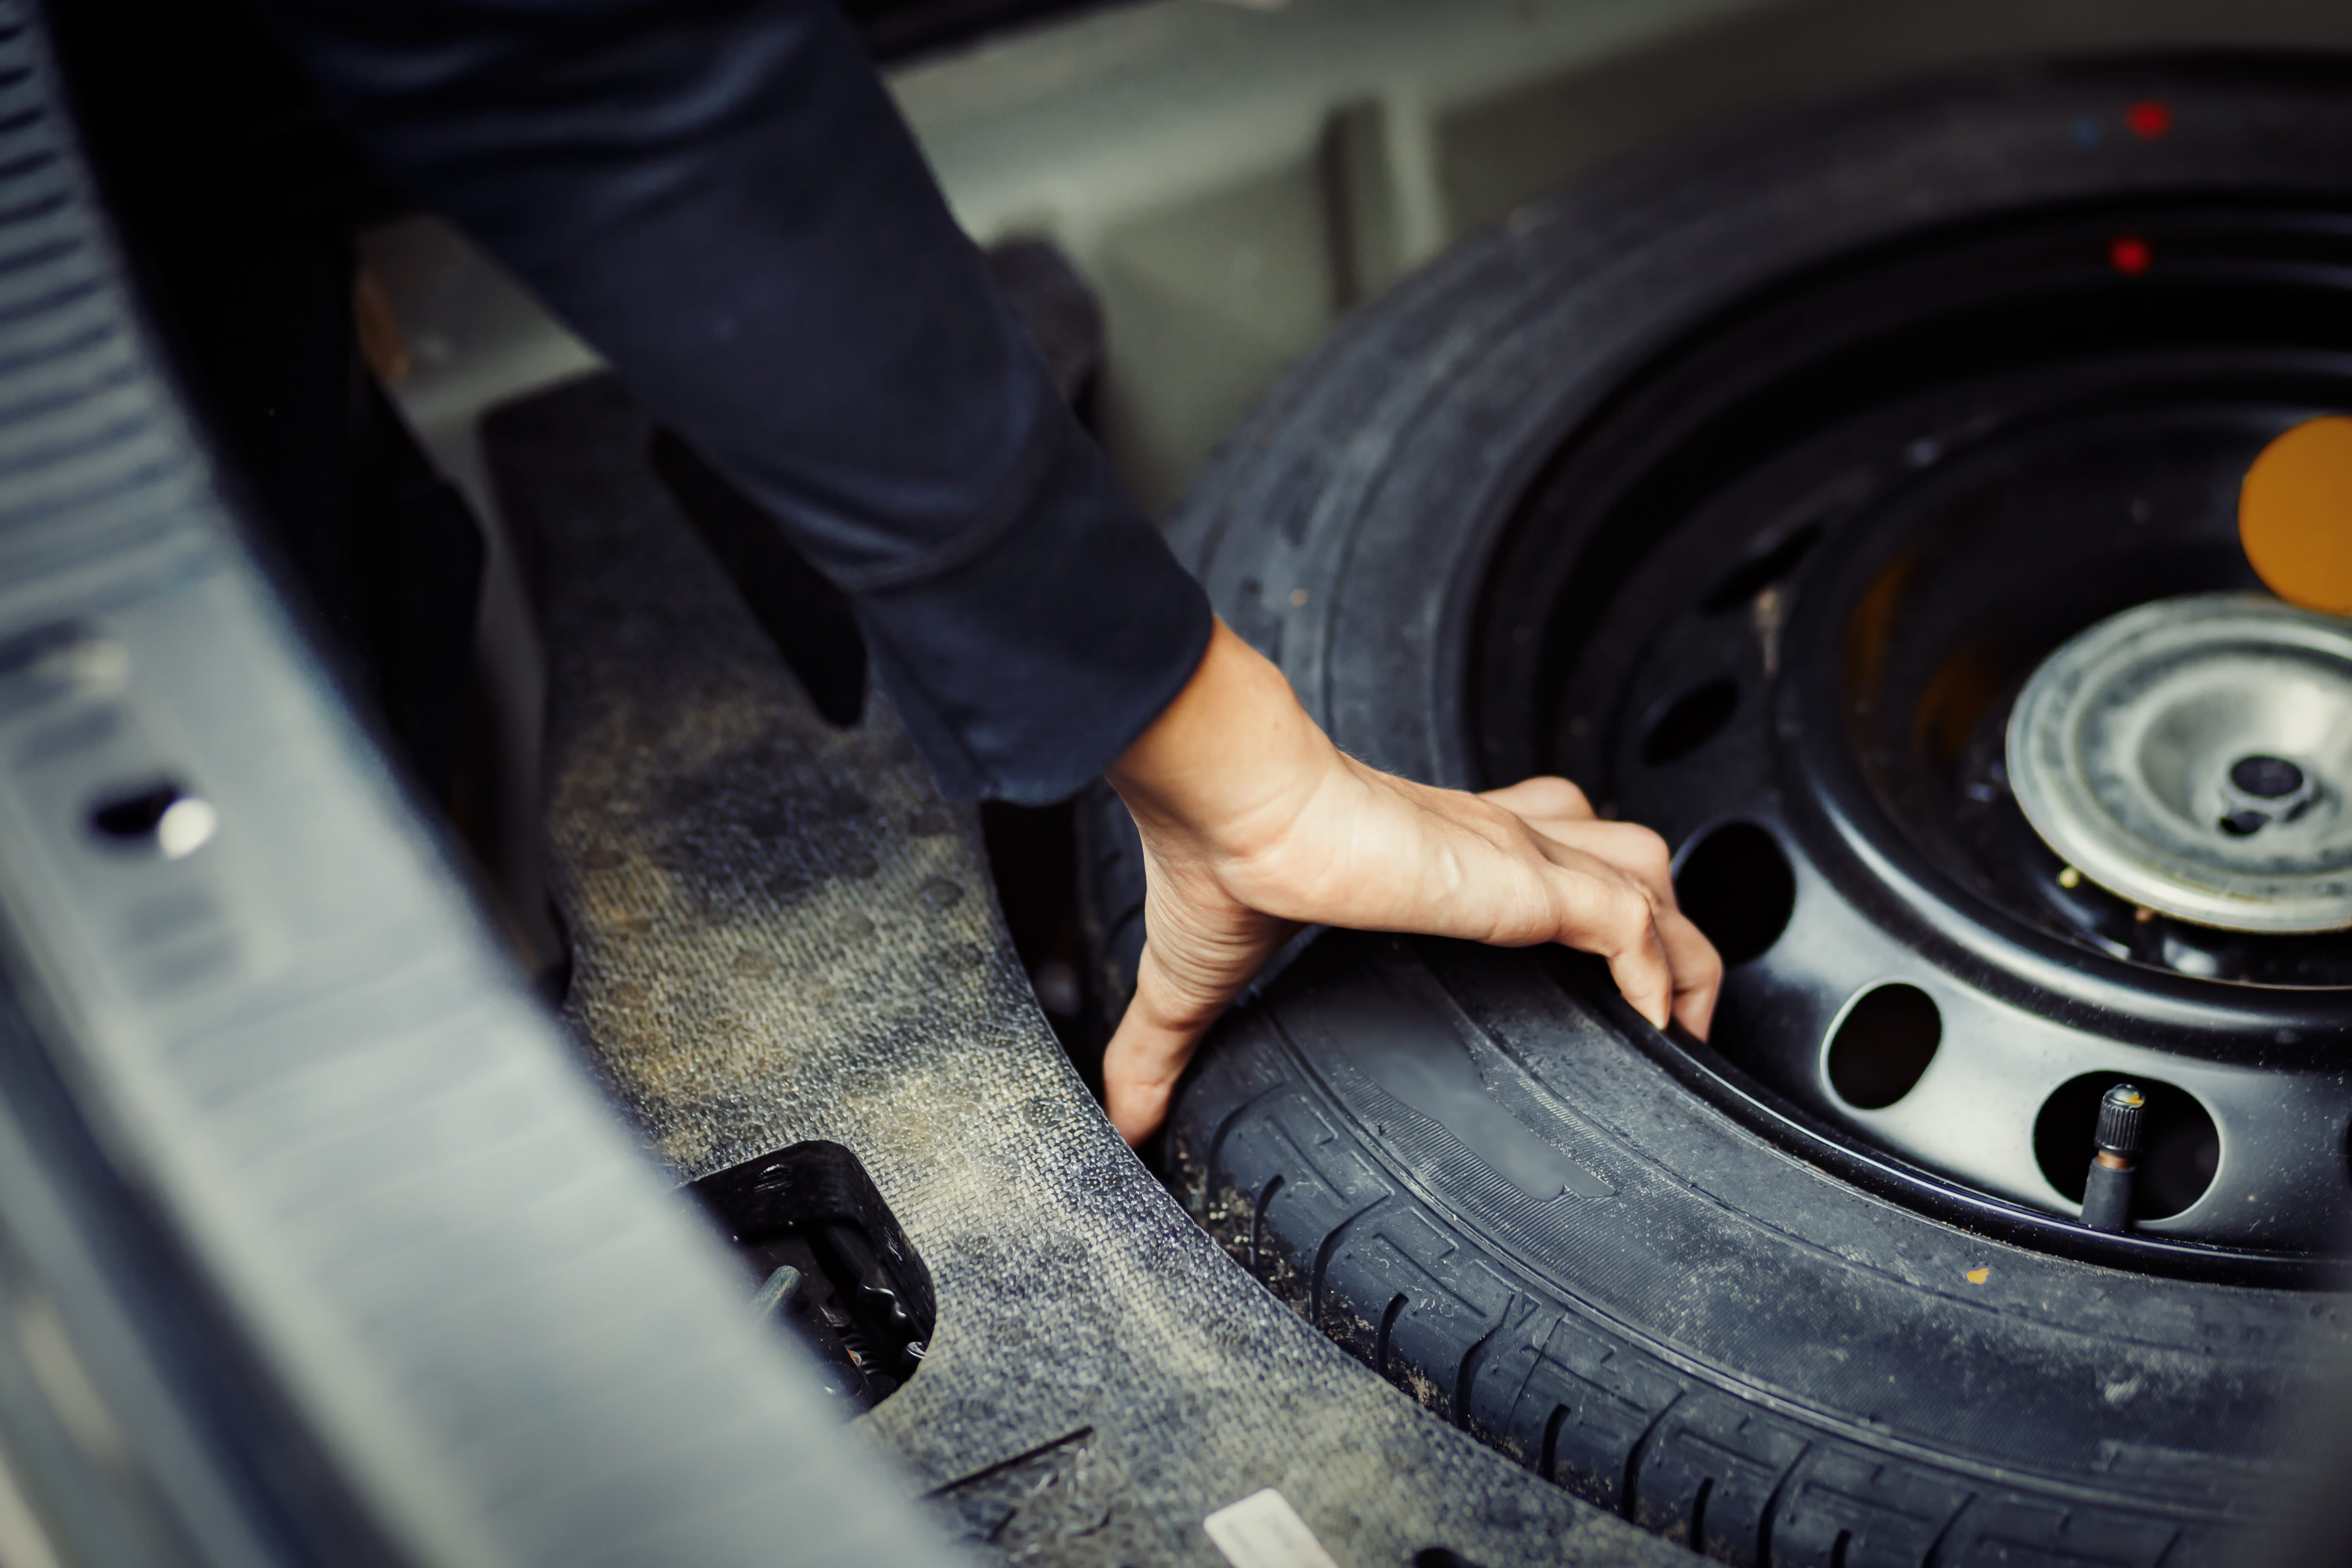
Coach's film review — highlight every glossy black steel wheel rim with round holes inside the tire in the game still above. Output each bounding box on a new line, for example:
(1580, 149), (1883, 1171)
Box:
(1472, 200), (2352, 1267)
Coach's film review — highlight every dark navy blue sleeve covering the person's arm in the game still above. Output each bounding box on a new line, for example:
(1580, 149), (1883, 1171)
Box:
(259, 0), (1209, 802)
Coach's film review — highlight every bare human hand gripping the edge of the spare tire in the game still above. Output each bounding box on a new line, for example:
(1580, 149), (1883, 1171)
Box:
(1103, 621), (1724, 1142)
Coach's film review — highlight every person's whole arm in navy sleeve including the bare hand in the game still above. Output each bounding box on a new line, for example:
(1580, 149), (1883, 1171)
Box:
(254, 0), (1719, 1138)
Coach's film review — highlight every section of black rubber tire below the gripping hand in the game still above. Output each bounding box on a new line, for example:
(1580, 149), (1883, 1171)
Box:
(1171, 933), (2343, 1568)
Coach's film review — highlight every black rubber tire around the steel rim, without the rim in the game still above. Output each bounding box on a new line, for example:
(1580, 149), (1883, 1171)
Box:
(1084, 61), (2352, 1568)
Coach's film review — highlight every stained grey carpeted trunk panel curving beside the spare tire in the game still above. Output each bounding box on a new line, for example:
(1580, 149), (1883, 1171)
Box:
(505, 379), (1684, 1568)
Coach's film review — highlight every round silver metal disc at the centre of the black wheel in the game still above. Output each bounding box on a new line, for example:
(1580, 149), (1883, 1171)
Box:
(2006, 595), (2352, 931)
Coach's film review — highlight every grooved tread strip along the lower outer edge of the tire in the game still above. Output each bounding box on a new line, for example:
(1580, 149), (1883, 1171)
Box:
(1174, 1030), (2227, 1568)
